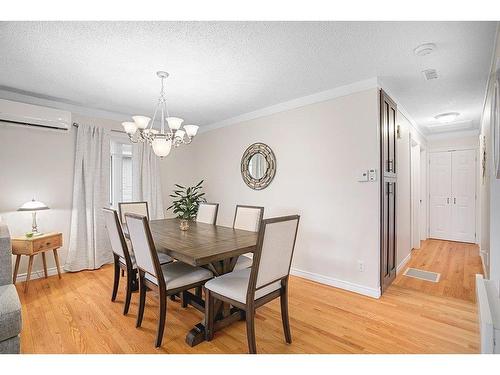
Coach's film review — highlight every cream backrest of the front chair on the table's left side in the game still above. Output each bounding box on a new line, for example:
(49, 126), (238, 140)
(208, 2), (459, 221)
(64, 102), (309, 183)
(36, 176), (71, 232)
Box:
(125, 213), (163, 281)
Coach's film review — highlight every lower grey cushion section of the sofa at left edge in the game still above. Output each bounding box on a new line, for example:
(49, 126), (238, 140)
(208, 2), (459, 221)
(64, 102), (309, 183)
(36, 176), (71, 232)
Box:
(0, 284), (21, 341)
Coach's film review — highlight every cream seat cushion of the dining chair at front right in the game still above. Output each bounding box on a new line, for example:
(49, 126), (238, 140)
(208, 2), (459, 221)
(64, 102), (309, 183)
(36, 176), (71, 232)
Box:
(205, 268), (281, 303)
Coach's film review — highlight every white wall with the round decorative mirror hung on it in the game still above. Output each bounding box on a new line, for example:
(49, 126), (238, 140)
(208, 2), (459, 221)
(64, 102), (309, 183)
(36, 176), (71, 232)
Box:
(162, 88), (380, 296)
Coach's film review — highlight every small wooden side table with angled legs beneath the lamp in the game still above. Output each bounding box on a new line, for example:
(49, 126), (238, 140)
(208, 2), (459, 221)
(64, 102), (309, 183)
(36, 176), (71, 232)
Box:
(11, 232), (62, 293)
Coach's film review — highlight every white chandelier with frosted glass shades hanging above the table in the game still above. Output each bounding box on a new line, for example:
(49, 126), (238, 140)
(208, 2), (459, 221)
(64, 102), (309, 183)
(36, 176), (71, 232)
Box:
(122, 71), (198, 159)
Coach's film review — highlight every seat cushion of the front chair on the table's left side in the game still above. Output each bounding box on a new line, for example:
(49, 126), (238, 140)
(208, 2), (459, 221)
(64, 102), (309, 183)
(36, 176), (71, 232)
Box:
(145, 262), (213, 290)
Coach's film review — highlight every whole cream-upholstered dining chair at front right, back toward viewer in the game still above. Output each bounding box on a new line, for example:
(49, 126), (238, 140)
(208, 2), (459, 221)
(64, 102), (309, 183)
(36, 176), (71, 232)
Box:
(205, 215), (300, 353)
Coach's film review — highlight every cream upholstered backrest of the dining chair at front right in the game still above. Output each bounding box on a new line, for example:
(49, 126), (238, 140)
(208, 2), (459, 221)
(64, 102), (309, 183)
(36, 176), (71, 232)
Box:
(248, 215), (300, 295)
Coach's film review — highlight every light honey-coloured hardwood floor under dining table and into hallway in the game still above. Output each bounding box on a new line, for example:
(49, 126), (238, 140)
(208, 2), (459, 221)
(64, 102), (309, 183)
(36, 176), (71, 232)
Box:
(17, 241), (479, 354)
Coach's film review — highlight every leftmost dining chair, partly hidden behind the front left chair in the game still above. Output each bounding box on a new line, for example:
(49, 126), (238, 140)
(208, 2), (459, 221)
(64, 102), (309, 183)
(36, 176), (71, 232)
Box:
(102, 208), (137, 315)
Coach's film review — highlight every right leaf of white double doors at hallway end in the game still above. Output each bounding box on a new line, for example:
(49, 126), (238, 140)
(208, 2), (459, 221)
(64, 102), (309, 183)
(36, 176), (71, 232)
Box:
(451, 150), (476, 242)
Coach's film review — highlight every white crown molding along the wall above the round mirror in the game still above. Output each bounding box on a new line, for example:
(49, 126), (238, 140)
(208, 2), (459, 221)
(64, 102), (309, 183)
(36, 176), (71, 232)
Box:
(200, 77), (378, 133)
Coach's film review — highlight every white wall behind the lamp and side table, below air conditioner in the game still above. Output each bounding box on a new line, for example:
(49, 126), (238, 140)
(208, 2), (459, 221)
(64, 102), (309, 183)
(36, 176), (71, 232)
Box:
(0, 114), (120, 280)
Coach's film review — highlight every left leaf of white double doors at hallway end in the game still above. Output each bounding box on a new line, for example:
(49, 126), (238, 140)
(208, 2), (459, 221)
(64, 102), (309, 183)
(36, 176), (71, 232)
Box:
(429, 152), (452, 240)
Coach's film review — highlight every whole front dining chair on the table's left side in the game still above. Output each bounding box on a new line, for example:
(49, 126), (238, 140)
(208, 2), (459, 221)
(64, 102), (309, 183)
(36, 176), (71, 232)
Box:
(125, 213), (213, 348)
